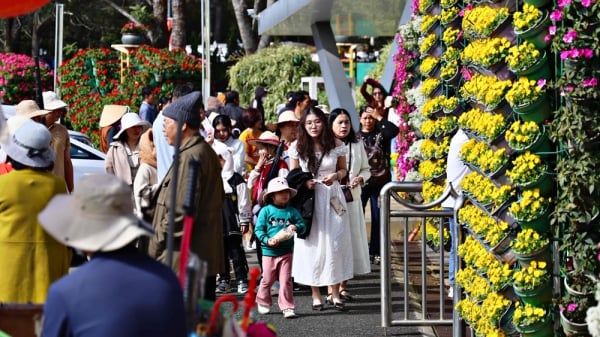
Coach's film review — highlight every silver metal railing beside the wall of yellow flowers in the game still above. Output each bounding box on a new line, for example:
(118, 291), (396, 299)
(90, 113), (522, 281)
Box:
(379, 182), (464, 336)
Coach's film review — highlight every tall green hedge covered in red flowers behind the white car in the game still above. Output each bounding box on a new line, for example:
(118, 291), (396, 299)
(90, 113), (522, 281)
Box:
(58, 46), (202, 143)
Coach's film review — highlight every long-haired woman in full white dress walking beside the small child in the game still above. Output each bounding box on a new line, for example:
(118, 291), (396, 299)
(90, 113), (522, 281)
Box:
(289, 108), (354, 311)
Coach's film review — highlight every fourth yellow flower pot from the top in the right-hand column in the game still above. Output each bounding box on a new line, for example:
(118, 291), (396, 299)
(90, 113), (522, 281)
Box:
(504, 120), (552, 155)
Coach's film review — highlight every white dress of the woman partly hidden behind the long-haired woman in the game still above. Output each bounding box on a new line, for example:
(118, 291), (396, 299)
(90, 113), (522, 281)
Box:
(346, 140), (371, 275)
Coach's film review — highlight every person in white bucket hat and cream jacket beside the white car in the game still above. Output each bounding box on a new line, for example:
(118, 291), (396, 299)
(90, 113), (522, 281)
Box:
(104, 112), (150, 186)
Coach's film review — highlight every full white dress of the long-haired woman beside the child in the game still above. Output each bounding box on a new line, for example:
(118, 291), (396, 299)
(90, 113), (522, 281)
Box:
(289, 144), (354, 286)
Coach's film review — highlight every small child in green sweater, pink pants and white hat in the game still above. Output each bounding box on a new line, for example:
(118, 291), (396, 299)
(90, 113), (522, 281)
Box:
(255, 177), (306, 318)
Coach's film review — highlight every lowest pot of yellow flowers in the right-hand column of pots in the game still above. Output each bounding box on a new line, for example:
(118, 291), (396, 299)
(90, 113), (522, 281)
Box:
(513, 301), (554, 336)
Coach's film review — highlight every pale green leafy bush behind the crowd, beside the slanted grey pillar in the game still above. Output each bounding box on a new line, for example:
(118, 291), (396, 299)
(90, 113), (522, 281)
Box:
(229, 45), (321, 121)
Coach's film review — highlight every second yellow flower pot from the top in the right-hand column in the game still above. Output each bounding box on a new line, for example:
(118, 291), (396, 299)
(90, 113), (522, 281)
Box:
(506, 41), (550, 80)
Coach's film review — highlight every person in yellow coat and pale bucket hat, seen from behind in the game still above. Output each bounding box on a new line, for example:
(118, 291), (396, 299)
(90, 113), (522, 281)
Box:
(0, 120), (71, 303)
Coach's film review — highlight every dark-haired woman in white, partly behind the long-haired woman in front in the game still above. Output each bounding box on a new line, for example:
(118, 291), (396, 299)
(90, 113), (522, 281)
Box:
(329, 108), (371, 301)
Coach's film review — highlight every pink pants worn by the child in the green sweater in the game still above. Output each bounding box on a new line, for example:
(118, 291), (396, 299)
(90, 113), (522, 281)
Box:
(256, 253), (294, 311)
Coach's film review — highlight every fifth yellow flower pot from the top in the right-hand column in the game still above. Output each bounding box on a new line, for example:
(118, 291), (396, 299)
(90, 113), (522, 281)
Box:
(506, 151), (554, 196)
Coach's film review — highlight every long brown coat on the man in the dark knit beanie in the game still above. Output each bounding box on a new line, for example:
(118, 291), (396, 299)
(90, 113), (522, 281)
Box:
(149, 135), (225, 275)
